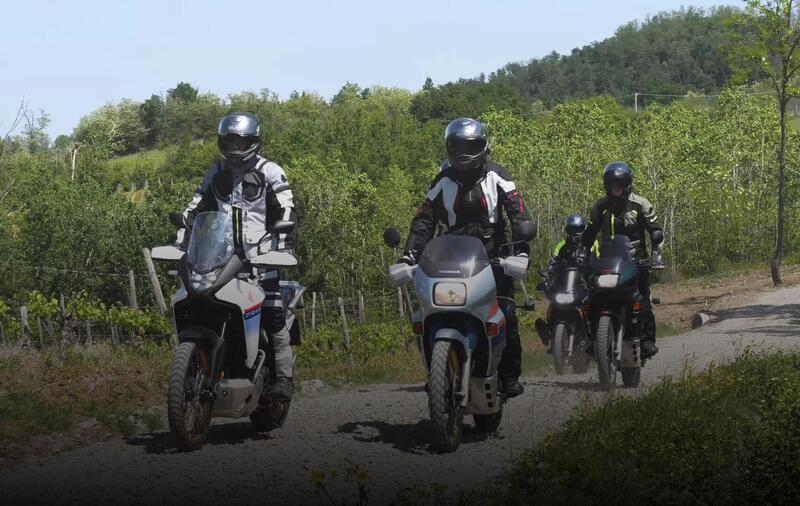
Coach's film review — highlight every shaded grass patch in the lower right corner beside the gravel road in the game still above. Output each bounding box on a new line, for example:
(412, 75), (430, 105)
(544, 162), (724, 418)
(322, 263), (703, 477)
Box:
(465, 353), (800, 504)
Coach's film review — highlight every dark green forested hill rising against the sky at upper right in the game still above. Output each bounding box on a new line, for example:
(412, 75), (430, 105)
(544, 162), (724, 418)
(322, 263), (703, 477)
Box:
(412, 7), (737, 120)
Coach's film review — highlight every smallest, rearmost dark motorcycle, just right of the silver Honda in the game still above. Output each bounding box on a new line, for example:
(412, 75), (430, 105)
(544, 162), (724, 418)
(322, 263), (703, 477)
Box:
(535, 254), (592, 374)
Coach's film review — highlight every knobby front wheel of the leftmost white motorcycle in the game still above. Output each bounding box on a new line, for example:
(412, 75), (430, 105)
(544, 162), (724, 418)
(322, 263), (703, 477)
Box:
(167, 343), (213, 450)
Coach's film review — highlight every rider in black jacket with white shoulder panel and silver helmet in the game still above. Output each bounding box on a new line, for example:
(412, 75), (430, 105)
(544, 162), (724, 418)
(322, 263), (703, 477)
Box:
(400, 118), (530, 397)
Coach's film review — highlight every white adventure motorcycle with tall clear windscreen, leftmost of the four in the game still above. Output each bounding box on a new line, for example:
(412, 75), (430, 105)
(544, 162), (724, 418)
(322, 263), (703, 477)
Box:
(151, 212), (305, 450)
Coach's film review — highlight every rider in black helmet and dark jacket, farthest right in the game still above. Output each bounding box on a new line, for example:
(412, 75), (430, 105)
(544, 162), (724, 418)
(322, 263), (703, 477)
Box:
(581, 161), (664, 358)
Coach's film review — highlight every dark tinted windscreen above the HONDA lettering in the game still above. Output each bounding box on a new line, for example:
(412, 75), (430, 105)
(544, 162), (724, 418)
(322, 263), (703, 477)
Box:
(419, 235), (489, 278)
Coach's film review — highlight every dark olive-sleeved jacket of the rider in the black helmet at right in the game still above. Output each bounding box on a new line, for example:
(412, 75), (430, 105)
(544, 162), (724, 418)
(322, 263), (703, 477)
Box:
(582, 192), (664, 261)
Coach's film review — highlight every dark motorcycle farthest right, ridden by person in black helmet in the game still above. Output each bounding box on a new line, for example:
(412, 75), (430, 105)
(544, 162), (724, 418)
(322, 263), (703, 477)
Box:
(587, 234), (647, 390)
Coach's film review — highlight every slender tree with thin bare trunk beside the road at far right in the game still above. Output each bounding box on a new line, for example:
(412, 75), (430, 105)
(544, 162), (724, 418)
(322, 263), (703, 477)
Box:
(731, 0), (800, 285)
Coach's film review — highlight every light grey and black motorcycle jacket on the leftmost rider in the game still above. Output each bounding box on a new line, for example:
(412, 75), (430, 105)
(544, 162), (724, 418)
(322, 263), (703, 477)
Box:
(183, 156), (297, 258)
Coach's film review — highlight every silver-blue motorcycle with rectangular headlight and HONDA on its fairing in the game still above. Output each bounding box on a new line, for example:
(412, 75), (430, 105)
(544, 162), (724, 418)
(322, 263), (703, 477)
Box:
(384, 222), (536, 452)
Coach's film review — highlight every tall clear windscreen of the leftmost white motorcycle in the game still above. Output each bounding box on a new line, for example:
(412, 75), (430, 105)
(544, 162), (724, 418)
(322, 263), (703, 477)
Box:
(186, 211), (233, 274)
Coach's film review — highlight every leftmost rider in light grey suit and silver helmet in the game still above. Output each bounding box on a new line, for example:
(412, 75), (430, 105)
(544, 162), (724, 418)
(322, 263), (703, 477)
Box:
(177, 113), (297, 400)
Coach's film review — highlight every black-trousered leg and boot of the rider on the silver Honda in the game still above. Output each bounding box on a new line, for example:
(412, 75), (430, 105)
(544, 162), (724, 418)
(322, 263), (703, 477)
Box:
(494, 269), (524, 397)
